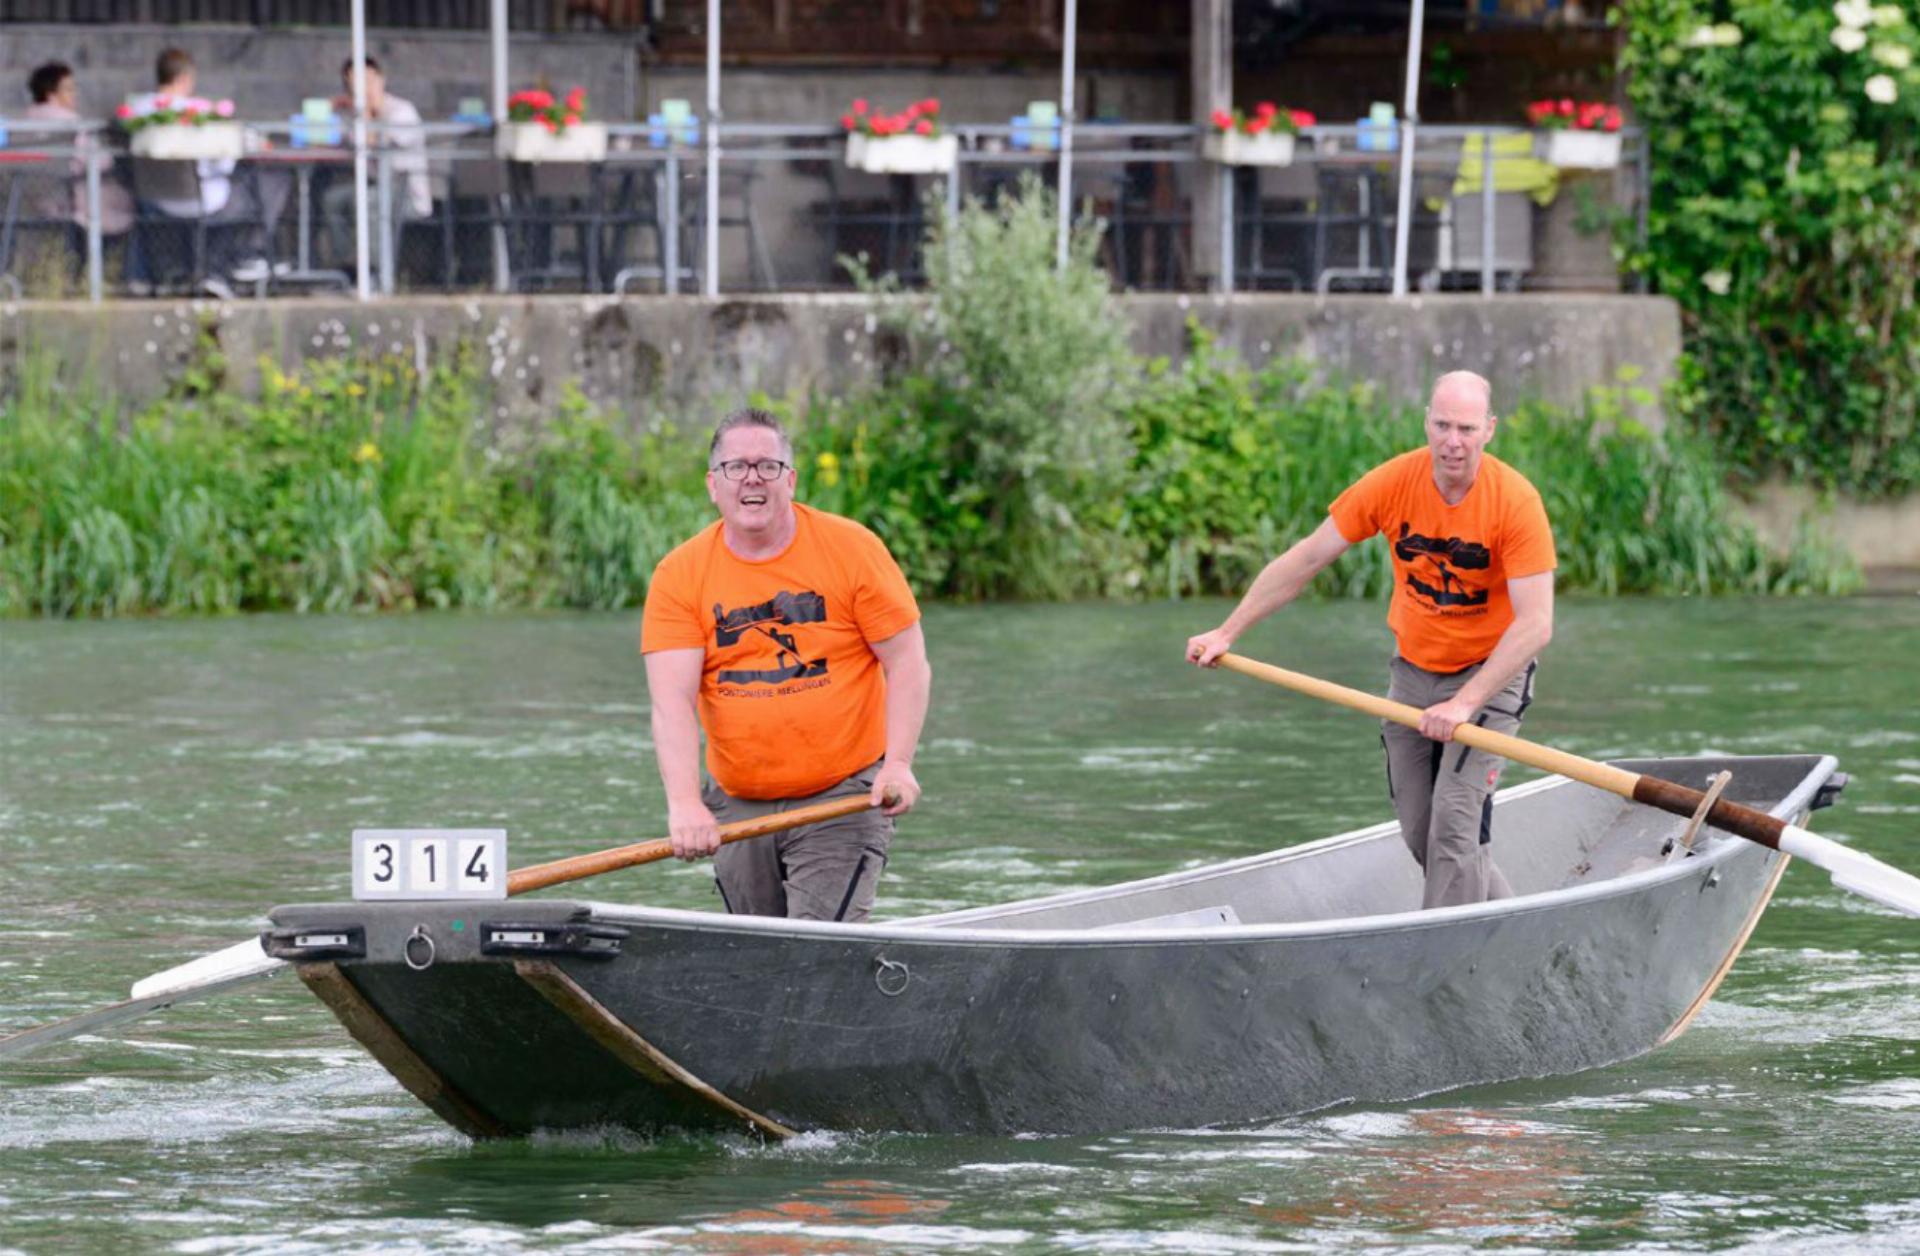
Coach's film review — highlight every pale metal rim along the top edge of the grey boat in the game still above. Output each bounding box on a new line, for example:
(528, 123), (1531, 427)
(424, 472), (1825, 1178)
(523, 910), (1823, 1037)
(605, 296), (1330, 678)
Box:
(529, 755), (1839, 949)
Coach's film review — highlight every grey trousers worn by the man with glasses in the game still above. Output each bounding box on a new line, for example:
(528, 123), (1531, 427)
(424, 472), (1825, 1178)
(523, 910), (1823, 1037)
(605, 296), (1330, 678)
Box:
(703, 762), (893, 922)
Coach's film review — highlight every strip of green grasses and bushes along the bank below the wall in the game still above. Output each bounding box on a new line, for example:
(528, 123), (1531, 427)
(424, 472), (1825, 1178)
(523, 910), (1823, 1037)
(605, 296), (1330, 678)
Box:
(0, 186), (1857, 616)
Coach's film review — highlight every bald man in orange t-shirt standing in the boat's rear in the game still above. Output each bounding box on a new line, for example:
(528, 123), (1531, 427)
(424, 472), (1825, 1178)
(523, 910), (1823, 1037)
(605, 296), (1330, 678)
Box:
(1187, 371), (1553, 906)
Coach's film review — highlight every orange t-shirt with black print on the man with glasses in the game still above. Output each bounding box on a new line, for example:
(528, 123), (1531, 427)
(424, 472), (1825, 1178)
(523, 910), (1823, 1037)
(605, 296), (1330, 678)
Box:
(639, 503), (920, 799)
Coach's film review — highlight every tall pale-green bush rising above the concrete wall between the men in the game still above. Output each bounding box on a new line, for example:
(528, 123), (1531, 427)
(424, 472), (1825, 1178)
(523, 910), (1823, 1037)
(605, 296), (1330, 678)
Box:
(840, 175), (1139, 599)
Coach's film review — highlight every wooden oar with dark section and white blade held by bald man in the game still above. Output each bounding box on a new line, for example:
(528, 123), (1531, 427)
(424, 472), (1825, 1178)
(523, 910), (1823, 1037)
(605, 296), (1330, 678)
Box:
(1219, 653), (1920, 916)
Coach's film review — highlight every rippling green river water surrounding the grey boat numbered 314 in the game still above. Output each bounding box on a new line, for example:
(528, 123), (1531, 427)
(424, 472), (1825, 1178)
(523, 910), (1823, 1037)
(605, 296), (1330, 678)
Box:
(0, 597), (1920, 1252)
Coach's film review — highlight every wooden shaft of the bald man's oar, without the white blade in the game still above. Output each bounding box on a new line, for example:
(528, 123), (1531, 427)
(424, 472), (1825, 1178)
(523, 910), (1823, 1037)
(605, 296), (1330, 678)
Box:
(1219, 653), (1786, 849)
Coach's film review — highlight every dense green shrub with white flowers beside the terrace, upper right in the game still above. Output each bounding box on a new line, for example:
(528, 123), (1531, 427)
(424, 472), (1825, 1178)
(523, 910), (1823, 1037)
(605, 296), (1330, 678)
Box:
(1622, 0), (1920, 495)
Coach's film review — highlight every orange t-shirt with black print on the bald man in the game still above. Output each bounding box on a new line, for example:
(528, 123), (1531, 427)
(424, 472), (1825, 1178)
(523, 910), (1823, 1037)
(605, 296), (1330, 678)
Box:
(1327, 449), (1553, 672)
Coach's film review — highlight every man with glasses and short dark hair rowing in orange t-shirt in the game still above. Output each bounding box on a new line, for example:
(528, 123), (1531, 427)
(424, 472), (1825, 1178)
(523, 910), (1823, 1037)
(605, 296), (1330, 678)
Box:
(639, 409), (933, 920)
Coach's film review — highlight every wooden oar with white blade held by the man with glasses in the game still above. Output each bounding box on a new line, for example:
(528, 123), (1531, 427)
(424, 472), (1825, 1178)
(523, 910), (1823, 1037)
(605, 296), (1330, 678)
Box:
(0, 793), (895, 1060)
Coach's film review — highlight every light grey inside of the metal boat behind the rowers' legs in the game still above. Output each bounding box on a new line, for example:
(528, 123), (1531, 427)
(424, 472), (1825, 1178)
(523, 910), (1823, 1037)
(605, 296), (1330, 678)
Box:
(899, 755), (1843, 930)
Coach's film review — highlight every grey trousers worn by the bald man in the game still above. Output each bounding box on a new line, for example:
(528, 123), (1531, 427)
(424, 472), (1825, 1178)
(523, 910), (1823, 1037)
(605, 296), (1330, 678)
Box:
(1380, 657), (1540, 908)
